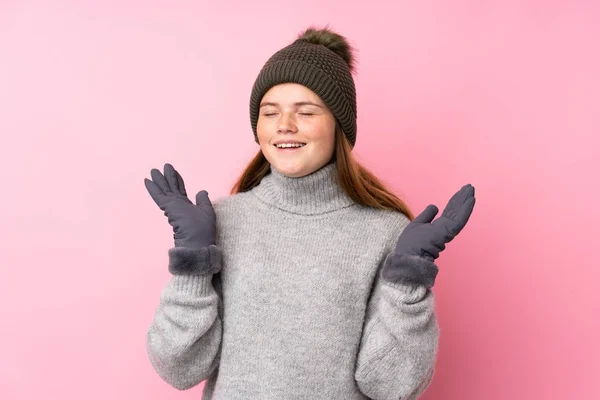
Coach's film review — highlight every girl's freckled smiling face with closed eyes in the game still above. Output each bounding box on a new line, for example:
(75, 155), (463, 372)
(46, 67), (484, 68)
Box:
(256, 83), (335, 177)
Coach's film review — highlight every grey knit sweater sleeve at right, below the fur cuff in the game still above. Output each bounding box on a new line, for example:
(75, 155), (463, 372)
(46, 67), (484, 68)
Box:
(355, 252), (439, 400)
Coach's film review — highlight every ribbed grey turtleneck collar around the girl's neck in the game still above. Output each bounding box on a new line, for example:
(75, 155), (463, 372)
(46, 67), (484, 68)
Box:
(252, 162), (354, 215)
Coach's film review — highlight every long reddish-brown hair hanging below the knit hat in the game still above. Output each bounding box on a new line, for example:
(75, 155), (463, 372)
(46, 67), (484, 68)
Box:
(231, 124), (414, 221)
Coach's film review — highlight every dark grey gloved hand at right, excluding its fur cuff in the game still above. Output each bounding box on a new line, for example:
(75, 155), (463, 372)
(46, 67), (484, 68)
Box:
(396, 184), (475, 261)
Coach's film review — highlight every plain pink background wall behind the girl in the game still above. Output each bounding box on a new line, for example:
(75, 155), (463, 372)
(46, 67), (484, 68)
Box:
(0, 0), (600, 400)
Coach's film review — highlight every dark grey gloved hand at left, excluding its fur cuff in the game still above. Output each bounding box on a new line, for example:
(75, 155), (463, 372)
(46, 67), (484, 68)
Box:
(144, 163), (217, 250)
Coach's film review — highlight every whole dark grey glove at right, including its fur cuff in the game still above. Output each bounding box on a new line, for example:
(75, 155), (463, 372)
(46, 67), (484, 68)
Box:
(382, 184), (475, 286)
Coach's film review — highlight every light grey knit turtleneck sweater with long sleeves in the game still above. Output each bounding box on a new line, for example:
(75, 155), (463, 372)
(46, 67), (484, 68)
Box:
(147, 164), (439, 400)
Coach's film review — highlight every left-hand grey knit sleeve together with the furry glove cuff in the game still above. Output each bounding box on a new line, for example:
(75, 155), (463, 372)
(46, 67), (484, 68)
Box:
(146, 246), (223, 390)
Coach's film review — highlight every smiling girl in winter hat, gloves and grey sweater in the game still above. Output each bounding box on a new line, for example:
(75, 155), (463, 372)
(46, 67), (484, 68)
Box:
(145, 28), (475, 400)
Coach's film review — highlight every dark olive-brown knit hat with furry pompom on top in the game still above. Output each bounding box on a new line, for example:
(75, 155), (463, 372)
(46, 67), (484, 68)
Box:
(250, 28), (356, 147)
